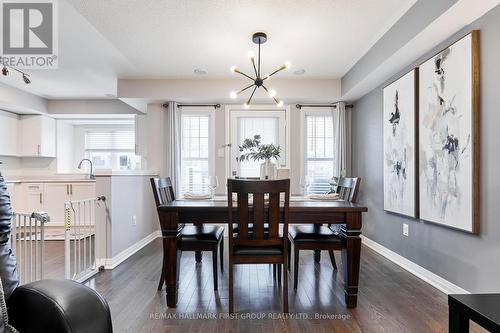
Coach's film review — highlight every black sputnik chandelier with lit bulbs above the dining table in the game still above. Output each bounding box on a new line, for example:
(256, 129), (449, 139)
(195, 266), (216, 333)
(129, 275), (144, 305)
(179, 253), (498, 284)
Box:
(230, 32), (291, 108)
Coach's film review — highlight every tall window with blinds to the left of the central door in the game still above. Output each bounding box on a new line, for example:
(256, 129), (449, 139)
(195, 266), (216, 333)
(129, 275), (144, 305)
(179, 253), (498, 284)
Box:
(178, 109), (213, 194)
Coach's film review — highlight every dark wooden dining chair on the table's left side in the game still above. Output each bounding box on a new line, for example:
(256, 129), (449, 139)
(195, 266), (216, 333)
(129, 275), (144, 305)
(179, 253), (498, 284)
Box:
(151, 177), (224, 290)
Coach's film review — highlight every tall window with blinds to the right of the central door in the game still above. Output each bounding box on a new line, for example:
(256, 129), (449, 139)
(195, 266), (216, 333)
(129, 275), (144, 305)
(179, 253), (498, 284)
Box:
(302, 110), (335, 195)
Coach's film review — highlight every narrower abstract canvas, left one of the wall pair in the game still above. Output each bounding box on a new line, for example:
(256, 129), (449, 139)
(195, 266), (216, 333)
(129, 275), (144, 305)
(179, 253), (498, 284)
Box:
(383, 70), (417, 217)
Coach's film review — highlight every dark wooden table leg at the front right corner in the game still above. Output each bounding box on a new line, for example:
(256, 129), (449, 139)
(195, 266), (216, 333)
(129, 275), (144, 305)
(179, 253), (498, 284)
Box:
(340, 213), (361, 308)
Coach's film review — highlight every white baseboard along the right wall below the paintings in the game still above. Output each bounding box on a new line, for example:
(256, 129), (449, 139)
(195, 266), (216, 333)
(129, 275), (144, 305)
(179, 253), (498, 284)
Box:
(361, 235), (469, 294)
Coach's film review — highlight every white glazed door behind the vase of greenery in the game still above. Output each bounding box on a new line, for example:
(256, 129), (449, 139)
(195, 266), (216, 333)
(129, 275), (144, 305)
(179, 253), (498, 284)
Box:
(228, 107), (289, 177)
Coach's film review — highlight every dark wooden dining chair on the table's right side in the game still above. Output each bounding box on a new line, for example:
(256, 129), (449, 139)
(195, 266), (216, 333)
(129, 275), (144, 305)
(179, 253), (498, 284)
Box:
(288, 177), (361, 289)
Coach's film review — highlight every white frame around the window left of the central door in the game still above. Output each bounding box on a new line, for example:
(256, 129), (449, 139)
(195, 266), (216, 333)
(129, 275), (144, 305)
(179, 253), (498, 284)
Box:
(180, 106), (215, 197)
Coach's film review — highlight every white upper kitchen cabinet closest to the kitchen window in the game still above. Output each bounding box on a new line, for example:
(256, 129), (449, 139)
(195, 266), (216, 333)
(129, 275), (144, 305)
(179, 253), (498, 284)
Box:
(18, 115), (56, 157)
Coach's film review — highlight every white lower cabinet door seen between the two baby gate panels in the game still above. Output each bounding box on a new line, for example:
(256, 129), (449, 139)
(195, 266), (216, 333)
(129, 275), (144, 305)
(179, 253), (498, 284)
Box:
(44, 183), (69, 225)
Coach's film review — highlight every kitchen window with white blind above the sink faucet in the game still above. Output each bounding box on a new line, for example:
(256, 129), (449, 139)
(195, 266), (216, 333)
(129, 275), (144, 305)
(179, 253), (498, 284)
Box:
(85, 127), (141, 170)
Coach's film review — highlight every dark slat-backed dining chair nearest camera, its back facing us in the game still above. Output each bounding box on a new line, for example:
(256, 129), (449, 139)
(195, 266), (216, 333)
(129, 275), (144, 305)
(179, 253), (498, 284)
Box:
(227, 179), (290, 313)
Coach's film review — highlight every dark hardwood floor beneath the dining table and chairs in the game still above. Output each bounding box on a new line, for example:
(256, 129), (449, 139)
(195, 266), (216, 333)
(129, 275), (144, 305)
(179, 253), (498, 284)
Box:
(46, 239), (485, 333)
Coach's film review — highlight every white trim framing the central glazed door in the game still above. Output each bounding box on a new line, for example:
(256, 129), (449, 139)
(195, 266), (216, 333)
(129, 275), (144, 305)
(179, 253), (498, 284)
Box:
(224, 105), (290, 178)
